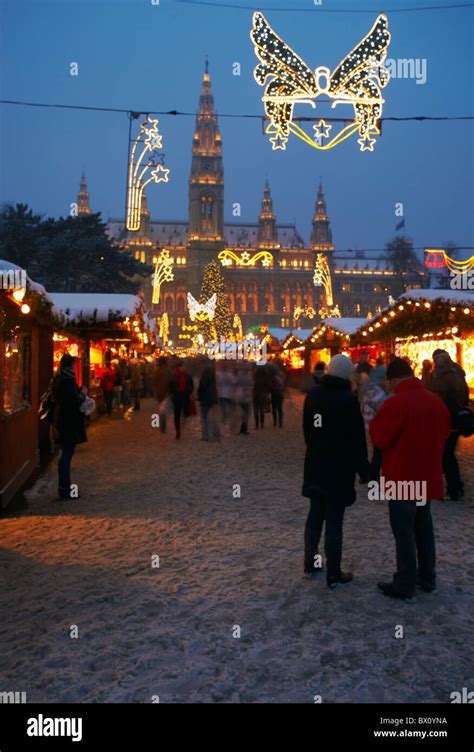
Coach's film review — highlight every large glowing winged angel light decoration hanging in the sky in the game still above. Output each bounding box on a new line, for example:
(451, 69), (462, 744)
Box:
(250, 12), (390, 151)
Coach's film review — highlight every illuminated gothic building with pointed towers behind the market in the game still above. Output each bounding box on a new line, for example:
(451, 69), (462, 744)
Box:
(93, 64), (422, 344)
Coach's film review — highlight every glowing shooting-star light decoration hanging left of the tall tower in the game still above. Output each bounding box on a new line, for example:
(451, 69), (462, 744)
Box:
(126, 117), (170, 231)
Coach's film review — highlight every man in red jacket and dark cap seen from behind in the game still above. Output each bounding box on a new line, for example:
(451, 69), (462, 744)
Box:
(369, 358), (451, 600)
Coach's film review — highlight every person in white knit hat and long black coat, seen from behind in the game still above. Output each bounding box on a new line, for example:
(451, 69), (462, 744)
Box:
(302, 355), (369, 588)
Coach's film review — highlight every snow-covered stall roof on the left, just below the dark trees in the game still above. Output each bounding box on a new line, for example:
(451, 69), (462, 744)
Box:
(50, 292), (142, 322)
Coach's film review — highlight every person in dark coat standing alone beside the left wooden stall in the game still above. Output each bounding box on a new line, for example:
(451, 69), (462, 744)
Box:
(52, 354), (87, 499)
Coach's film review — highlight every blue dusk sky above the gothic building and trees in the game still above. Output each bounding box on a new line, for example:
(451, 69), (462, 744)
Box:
(0, 0), (474, 256)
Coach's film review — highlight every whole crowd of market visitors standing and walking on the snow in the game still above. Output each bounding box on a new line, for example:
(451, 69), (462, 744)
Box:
(52, 350), (472, 601)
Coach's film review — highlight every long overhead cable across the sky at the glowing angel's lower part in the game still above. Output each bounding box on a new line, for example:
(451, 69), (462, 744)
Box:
(0, 99), (474, 123)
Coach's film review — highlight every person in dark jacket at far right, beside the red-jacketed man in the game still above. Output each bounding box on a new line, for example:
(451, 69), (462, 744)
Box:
(426, 350), (469, 501)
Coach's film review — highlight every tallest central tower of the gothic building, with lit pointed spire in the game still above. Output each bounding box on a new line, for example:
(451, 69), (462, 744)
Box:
(189, 63), (224, 241)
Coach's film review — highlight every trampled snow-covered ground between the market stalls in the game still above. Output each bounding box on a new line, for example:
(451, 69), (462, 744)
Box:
(0, 393), (474, 703)
